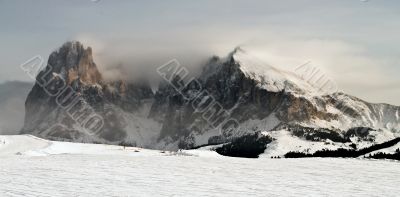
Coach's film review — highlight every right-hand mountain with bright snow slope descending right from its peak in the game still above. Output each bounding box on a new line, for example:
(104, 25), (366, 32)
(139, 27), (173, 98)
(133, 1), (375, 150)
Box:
(153, 49), (400, 148)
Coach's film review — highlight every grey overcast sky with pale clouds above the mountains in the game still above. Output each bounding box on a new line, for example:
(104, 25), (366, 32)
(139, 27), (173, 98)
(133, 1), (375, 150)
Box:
(0, 0), (400, 105)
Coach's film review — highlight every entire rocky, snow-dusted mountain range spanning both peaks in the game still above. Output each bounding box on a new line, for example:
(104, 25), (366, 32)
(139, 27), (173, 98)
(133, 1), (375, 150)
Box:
(22, 42), (400, 152)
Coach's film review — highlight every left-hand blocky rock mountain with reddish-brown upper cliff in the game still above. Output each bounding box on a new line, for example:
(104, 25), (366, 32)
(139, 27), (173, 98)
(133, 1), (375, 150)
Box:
(22, 42), (153, 143)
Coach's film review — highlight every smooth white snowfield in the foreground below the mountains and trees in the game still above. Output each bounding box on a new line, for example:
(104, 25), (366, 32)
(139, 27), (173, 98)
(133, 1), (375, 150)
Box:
(0, 135), (400, 197)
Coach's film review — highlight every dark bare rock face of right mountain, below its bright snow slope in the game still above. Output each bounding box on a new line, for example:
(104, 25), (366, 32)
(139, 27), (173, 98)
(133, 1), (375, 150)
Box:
(150, 57), (324, 148)
